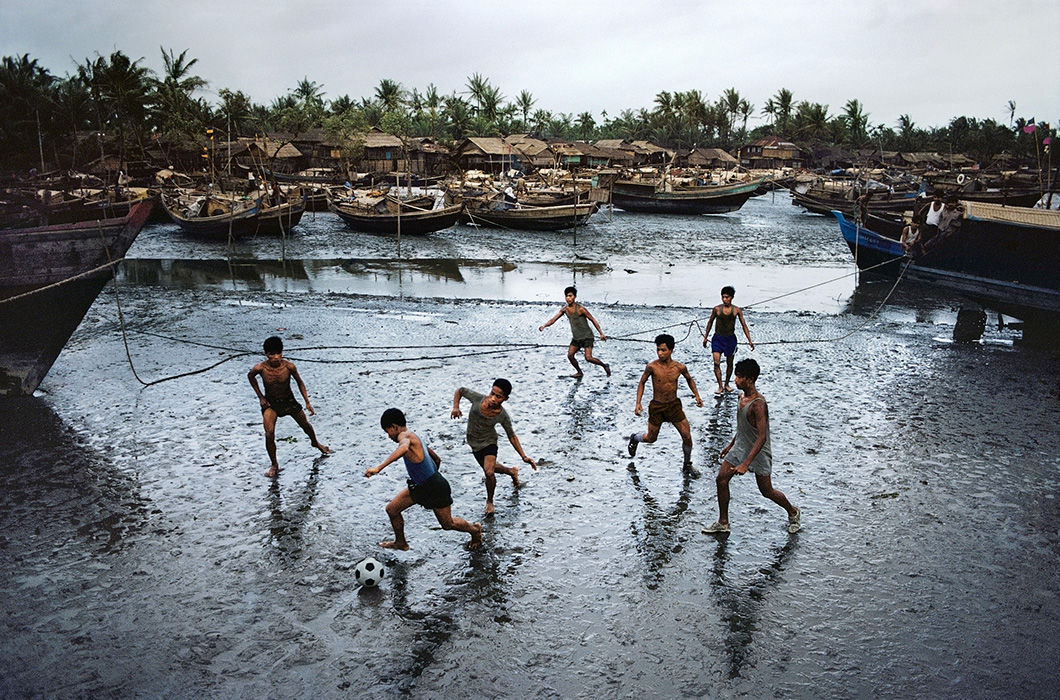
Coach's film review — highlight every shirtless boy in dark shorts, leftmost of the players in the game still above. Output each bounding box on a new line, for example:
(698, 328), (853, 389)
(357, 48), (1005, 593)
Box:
(247, 335), (331, 478)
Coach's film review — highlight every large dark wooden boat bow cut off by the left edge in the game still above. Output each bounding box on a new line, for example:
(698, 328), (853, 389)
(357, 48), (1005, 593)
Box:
(0, 198), (156, 396)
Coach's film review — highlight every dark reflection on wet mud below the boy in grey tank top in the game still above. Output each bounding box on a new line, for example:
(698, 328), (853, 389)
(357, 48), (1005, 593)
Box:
(710, 535), (798, 679)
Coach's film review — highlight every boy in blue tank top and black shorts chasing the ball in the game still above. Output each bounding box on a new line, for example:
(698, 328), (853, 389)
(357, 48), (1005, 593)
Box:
(365, 408), (482, 550)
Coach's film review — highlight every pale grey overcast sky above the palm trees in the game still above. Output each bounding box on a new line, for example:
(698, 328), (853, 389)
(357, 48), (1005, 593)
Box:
(0, 0), (1060, 132)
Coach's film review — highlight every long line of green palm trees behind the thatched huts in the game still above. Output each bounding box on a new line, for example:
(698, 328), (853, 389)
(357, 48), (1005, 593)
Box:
(0, 48), (1055, 171)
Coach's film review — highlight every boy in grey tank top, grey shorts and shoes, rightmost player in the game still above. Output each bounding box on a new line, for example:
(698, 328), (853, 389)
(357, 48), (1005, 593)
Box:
(703, 358), (802, 535)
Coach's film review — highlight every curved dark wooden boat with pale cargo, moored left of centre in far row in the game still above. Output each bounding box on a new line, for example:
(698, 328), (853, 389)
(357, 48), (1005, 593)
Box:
(331, 190), (463, 235)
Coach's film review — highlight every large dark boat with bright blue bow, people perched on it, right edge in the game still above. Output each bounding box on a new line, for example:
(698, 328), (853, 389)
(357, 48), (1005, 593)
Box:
(832, 200), (1060, 338)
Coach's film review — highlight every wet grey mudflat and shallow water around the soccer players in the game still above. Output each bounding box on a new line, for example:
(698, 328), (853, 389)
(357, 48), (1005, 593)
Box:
(0, 196), (1060, 698)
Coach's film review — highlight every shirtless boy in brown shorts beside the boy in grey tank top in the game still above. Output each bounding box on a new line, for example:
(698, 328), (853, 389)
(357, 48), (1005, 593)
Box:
(626, 333), (703, 476)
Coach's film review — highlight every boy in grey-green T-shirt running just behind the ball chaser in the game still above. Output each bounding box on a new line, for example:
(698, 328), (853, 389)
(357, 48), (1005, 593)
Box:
(451, 379), (537, 515)
